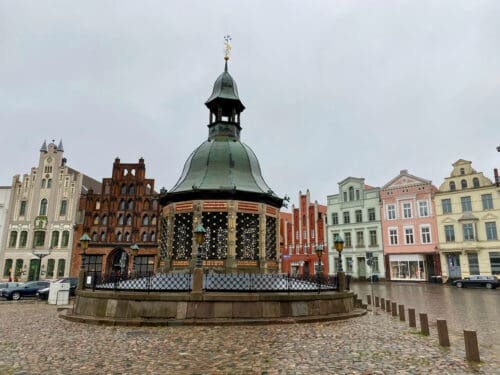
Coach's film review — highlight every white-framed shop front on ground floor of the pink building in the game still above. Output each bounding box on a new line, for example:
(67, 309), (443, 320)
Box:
(389, 254), (427, 281)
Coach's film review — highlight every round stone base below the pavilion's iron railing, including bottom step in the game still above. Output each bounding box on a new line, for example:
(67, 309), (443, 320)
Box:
(60, 290), (366, 326)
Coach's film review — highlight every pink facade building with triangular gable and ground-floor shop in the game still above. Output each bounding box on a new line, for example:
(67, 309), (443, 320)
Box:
(380, 170), (441, 281)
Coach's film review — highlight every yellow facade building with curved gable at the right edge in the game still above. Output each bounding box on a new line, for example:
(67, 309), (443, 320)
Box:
(435, 159), (500, 281)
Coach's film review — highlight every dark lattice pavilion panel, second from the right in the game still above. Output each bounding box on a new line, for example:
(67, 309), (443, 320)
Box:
(236, 212), (259, 259)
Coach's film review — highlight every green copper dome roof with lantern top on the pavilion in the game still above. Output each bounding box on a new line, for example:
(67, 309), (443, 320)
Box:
(161, 62), (282, 208)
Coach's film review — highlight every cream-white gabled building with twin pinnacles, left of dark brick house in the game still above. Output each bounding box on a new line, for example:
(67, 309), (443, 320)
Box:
(0, 142), (100, 281)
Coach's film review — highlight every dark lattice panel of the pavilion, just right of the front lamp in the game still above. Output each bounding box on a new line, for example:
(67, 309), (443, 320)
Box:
(201, 212), (228, 259)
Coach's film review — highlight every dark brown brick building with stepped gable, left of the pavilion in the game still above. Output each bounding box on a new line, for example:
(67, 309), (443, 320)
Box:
(71, 158), (160, 276)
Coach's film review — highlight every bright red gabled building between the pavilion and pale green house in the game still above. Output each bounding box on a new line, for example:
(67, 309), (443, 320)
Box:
(280, 190), (329, 276)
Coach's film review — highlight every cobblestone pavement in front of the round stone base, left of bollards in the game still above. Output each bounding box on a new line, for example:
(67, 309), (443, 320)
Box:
(0, 301), (500, 375)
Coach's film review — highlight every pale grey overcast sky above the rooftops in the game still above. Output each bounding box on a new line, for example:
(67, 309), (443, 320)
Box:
(0, 0), (500, 209)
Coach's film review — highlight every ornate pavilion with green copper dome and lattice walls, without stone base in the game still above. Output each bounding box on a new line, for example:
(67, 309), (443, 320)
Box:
(160, 54), (283, 273)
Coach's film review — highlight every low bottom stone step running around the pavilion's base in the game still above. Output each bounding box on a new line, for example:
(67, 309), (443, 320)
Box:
(59, 309), (366, 327)
